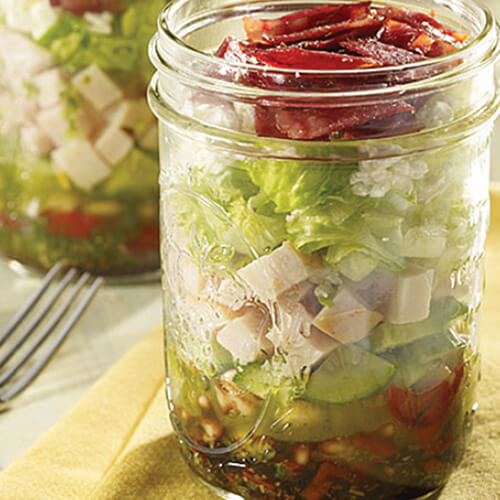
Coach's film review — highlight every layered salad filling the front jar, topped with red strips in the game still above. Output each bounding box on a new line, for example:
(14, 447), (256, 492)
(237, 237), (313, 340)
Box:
(160, 2), (489, 500)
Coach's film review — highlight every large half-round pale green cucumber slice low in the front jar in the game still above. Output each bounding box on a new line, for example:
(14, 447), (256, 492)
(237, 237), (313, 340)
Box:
(303, 344), (396, 404)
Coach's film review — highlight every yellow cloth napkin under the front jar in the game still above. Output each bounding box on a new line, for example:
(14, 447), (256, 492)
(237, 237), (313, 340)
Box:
(0, 186), (500, 500)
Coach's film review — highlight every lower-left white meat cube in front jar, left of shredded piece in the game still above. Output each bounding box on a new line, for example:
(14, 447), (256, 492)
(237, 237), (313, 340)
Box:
(217, 308), (273, 364)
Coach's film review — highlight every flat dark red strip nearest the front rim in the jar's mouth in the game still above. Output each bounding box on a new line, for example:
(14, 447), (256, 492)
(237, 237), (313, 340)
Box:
(248, 47), (380, 71)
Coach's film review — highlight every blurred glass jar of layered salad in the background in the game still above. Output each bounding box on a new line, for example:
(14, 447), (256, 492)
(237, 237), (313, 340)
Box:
(0, 0), (165, 276)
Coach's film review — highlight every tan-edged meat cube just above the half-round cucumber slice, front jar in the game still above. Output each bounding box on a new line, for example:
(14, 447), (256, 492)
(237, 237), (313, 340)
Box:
(313, 288), (383, 344)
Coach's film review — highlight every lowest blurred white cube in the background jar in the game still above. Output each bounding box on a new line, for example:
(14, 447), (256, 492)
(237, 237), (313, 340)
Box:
(52, 139), (111, 191)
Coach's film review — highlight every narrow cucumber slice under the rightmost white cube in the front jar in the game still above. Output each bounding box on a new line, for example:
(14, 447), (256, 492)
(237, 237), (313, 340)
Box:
(368, 296), (467, 354)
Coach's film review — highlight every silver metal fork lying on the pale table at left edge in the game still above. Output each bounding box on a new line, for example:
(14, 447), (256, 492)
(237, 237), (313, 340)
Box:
(0, 264), (104, 404)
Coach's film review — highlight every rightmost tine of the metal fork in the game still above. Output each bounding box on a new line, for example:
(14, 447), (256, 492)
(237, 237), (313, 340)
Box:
(0, 273), (104, 403)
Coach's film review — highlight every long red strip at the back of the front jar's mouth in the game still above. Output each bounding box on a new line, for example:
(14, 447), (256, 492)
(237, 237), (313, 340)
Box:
(243, 2), (371, 41)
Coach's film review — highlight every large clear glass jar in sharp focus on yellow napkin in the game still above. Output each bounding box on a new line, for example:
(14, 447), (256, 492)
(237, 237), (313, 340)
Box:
(149, 0), (498, 500)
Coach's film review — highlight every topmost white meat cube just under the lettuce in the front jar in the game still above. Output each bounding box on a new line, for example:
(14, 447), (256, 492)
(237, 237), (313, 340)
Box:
(238, 242), (317, 300)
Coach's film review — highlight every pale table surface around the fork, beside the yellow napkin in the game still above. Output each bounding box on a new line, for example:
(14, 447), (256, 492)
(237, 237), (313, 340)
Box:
(0, 0), (500, 470)
